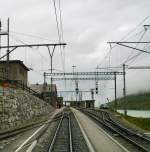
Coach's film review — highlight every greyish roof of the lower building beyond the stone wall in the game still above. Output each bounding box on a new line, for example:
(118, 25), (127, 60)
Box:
(30, 84), (57, 93)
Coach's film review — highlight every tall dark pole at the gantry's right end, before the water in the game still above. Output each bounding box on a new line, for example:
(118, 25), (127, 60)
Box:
(123, 64), (127, 116)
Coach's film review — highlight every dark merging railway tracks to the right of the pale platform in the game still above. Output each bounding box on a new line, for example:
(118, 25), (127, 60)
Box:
(81, 109), (150, 152)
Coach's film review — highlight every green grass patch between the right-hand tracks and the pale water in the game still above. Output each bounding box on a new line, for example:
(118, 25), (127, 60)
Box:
(124, 116), (150, 131)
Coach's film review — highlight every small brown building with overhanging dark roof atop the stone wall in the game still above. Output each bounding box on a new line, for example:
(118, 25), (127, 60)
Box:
(0, 60), (29, 85)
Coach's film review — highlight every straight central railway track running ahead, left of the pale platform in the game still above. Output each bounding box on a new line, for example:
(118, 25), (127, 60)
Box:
(48, 110), (89, 152)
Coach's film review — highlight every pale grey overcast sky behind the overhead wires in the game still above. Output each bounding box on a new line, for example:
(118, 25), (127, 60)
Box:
(0, 0), (150, 105)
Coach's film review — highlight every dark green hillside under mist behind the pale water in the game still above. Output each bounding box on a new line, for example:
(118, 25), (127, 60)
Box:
(109, 93), (150, 110)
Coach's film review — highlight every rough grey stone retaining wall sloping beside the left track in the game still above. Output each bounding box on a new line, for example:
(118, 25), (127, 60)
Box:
(0, 90), (54, 132)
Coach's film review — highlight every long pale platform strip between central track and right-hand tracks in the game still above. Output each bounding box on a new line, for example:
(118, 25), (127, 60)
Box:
(72, 108), (129, 152)
